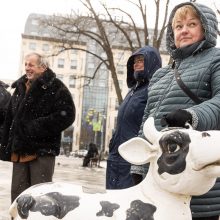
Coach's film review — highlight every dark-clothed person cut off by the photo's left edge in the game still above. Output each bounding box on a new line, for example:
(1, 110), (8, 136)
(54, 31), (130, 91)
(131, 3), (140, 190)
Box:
(0, 81), (11, 144)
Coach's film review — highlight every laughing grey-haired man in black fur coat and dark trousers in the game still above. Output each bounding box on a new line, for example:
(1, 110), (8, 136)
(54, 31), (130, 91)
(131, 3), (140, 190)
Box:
(2, 53), (75, 202)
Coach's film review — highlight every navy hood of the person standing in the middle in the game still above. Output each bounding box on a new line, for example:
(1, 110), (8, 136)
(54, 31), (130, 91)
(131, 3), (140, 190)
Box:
(127, 46), (161, 88)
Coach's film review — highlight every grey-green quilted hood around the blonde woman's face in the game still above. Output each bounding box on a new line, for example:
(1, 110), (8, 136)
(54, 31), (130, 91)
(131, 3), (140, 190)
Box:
(166, 2), (218, 59)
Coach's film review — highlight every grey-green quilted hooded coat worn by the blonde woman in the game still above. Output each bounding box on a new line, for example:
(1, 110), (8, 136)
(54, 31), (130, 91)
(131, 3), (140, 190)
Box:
(131, 2), (220, 217)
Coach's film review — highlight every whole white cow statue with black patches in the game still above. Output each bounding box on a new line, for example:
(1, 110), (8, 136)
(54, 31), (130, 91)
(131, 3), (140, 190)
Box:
(9, 118), (220, 220)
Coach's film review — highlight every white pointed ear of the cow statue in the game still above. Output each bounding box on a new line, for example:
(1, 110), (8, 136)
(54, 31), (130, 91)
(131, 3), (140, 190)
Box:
(118, 137), (157, 165)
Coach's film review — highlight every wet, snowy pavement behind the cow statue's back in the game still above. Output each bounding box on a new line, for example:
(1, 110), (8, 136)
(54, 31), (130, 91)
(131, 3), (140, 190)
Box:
(0, 156), (106, 220)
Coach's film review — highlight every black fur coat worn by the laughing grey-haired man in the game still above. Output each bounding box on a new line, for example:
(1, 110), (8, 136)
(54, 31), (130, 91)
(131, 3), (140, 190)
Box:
(2, 69), (75, 156)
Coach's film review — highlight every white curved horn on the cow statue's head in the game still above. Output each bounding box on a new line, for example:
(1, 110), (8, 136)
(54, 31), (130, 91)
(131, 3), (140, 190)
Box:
(143, 117), (160, 143)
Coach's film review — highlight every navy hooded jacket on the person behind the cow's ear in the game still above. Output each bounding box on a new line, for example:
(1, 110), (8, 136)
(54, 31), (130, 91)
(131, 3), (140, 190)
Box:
(108, 46), (161, 163)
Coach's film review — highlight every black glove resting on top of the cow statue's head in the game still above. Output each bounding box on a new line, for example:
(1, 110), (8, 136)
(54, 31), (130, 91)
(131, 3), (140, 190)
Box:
(160, 109), (192, 128)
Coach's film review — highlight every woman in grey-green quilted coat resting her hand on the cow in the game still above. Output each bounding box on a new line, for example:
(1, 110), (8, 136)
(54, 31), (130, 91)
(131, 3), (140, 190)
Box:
(131, 2), (220, 220)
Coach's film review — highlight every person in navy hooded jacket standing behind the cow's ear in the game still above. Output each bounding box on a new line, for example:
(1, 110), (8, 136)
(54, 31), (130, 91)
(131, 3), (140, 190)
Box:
(106, 46), (161, 189)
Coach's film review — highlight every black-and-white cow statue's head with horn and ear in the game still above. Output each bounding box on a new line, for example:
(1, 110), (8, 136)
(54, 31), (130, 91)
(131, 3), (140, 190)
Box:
(119, 118), (220, 195)
